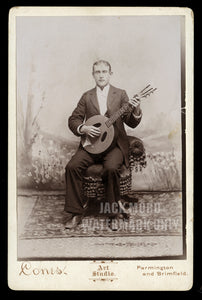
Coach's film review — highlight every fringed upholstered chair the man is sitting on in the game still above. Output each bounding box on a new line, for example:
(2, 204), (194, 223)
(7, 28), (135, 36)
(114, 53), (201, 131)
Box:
(83, 136), (146, 206)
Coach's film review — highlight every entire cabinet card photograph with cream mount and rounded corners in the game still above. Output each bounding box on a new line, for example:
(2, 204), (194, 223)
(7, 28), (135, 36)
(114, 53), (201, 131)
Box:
(8, 7), (193, 290)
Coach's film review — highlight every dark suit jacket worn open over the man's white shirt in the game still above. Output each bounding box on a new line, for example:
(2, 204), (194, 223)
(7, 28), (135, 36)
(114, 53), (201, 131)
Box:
(68, 85), (141, 167)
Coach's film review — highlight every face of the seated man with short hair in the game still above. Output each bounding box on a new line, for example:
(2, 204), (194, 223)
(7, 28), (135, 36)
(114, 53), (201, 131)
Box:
(93, 63), (112, 88)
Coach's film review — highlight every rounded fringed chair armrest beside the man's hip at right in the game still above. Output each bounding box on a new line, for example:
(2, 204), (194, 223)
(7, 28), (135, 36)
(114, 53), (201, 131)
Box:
(128, 136), (147, 172)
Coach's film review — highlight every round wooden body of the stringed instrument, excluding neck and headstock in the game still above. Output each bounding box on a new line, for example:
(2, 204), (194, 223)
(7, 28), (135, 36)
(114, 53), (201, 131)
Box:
(81, 115), (114, 154)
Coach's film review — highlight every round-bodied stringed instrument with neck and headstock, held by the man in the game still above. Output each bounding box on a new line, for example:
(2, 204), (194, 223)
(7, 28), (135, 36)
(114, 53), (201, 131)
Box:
(81, 84), (157, 154)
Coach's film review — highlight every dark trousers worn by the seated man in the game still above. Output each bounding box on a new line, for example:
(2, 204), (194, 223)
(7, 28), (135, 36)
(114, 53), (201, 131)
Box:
(64, 146), (123, 214)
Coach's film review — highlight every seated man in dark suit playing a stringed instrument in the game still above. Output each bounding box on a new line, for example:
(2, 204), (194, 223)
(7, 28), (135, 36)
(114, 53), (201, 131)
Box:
(64, 60), (142, 229)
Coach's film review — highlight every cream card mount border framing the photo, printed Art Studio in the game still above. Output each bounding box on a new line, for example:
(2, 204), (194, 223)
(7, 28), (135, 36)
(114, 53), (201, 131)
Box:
(8, 7), (193, 290)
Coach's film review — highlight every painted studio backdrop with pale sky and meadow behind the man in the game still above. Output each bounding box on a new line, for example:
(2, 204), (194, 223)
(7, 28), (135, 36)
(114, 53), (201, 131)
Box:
(16, 16), (183, 191)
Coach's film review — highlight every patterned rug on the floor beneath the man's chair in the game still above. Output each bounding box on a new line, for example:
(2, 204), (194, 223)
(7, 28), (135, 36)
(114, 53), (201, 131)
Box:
(19, 192), (182, 239)
